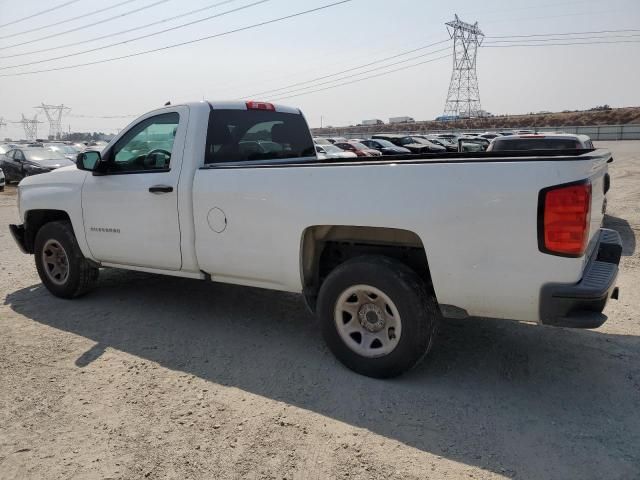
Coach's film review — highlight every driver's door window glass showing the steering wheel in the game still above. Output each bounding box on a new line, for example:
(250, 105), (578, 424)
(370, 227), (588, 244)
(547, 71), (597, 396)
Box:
(110, 112), (180, 173)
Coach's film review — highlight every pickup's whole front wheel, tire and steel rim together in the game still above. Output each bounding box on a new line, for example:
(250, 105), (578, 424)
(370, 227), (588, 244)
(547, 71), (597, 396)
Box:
(34, 221), (99, 298)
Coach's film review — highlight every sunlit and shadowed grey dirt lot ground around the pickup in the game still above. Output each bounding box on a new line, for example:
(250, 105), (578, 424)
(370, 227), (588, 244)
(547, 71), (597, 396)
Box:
(0, 142), (640, 480)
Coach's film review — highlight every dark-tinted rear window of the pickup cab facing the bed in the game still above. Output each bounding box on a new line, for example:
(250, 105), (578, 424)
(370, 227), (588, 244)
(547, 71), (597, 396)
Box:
(205, 110), (315, 163)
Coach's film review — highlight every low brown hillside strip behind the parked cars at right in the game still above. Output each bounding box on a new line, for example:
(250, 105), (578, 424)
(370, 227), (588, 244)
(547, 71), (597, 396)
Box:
(311, 107), (640, 135)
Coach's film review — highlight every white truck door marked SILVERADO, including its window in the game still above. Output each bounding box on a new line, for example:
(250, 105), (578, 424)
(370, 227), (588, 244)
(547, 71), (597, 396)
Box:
(82, 106), (189, 270)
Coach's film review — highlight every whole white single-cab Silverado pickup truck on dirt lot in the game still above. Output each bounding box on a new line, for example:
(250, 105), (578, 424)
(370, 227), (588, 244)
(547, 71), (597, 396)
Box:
(10, 102), (621, 377)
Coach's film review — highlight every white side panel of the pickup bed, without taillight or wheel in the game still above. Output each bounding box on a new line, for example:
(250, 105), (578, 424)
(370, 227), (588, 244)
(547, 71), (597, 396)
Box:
(193, 150), (611, 320)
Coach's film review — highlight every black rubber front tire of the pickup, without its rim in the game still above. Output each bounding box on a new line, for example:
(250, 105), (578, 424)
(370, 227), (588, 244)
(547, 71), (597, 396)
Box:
(34, 221), (99, 298)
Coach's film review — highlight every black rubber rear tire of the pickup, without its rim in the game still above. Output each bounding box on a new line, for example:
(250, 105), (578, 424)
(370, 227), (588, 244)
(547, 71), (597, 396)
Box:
(317, 256), (440, 378)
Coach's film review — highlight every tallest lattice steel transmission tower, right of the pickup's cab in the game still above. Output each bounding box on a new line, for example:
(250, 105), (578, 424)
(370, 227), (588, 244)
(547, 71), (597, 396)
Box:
(444, 15), (484, 119)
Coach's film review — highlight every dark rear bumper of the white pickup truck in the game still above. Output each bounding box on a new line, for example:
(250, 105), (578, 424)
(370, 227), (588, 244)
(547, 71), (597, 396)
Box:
(540, 228), (622, 328)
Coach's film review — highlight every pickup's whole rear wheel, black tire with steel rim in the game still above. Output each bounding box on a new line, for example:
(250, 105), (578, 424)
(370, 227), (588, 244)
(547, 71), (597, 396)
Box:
(317, 256), (440, 378)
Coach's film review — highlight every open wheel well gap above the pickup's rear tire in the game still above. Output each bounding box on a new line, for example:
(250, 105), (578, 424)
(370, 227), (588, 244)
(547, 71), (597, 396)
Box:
(300, 225), (435, 310)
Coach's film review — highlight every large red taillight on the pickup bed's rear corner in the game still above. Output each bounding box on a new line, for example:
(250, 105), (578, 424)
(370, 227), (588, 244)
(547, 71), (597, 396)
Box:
(538, 181), (591, 257)
